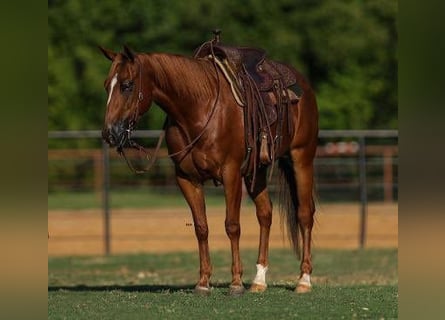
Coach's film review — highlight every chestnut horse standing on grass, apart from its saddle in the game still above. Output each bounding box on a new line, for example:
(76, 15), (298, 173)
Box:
(100, 46), (318, 295)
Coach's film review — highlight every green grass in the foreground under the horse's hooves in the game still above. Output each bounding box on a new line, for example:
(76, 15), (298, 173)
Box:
(48, 249), (398, 319)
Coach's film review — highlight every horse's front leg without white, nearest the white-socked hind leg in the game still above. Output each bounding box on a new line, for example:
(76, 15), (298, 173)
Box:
(223, 170), (245, 295)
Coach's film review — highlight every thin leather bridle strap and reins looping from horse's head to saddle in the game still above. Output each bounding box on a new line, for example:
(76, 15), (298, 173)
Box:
(118, 40), (221, 174)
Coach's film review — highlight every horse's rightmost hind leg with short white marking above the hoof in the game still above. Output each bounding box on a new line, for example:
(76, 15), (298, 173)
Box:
(291, 148), (315, 293)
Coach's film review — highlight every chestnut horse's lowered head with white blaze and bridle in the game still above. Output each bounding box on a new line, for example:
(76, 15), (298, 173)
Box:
(100, 46), (152, 152)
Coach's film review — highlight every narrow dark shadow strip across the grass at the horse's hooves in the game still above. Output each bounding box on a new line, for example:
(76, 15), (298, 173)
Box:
(48, 283), (295, 293)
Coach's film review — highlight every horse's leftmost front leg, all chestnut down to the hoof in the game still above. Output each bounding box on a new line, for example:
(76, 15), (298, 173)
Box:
(176, 176), (212, 294)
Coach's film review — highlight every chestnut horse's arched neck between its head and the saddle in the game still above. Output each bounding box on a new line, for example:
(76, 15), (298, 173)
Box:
(146, 54), (215, 123)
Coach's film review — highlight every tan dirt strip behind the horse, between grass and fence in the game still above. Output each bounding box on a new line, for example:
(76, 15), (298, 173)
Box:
(48, 203), (398, 256)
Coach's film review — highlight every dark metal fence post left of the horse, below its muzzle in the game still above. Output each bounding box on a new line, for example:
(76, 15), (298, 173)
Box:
(102, 141), (111, 255)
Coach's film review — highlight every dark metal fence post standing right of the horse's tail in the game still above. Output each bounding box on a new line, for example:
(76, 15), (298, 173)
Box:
(359, 136), (368, 249)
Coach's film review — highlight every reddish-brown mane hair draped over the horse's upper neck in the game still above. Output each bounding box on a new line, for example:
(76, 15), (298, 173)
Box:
(146, 53), (216, 99)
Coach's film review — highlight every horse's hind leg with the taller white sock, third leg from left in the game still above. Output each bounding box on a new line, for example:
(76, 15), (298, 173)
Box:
(245, 168), (272, 292)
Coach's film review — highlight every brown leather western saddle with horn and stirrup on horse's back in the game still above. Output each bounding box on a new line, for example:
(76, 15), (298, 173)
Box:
(194, 30), (303, 190)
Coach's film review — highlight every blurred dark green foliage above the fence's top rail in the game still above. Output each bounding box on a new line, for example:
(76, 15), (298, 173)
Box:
(48, 0), (398, 134)
